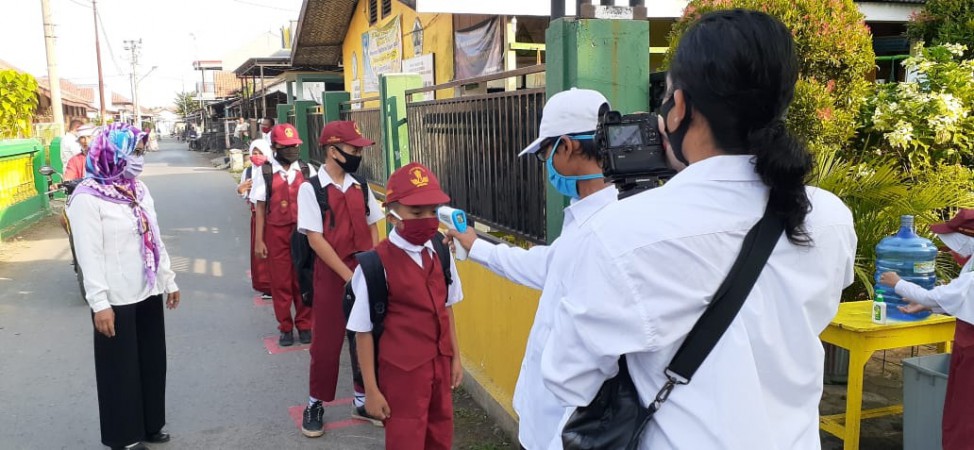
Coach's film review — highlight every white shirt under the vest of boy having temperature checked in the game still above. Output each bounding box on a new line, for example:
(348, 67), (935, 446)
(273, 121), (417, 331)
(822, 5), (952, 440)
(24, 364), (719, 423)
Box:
(347, 230), (463, 333)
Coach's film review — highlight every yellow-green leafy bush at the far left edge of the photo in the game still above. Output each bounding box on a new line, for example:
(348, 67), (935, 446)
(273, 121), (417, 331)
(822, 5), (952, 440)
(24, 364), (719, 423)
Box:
(0, 70), (37, 139)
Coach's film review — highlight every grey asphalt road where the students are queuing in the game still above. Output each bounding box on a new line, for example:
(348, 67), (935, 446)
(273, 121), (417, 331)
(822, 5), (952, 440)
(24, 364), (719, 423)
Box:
(0, 141), (384, 450)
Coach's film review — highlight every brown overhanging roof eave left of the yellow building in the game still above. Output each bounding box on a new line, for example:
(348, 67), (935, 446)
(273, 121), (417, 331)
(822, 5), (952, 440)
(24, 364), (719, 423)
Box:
(291, 0), (357, 70)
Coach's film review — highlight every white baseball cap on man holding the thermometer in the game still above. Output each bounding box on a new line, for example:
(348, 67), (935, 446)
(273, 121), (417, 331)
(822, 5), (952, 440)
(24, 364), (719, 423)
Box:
(517, 88), (609, 157)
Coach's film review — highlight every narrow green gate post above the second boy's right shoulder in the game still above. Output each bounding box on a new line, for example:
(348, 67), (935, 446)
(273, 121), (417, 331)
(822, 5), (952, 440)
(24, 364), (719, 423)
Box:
(379, 73), (423, 179)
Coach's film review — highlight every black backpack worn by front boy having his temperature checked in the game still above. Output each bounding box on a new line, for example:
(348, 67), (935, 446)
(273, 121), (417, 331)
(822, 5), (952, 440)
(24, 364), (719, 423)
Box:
(342, 232), (453, 355)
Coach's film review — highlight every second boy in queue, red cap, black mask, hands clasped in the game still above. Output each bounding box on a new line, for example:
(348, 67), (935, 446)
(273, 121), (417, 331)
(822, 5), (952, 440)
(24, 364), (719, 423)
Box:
(298, 121), (383, 437)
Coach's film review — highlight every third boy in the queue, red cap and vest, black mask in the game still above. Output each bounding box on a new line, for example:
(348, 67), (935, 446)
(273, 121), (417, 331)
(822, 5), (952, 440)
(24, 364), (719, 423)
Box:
(250, 123), (313, 347)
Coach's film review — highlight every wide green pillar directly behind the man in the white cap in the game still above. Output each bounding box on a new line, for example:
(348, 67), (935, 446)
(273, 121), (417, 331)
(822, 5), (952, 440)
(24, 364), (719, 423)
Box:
(545, 19), (649, 242)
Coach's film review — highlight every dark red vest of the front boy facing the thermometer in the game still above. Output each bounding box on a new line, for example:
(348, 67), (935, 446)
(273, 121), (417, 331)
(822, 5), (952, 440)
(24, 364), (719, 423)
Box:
(375, 240), (453, 371)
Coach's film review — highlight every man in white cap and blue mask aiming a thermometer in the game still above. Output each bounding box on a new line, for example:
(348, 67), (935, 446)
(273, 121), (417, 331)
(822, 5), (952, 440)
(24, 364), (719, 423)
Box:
(450, 89), (618, 450)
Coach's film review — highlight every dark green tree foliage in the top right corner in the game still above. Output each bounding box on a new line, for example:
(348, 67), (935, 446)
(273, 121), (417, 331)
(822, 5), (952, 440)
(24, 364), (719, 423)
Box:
(907, 0), (974, 59)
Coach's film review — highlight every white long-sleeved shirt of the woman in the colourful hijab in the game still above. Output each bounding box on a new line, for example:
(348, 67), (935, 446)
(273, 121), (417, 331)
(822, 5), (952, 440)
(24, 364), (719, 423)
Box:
(68, 183), (179, 312)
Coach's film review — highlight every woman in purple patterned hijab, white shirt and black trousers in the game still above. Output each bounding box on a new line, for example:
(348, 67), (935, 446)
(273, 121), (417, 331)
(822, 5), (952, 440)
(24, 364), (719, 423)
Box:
(68, 124), (179, 449)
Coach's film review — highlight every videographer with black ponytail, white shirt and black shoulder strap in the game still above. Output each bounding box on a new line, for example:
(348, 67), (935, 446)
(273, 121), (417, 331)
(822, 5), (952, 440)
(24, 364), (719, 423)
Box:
(542, 10), (856, 450)
